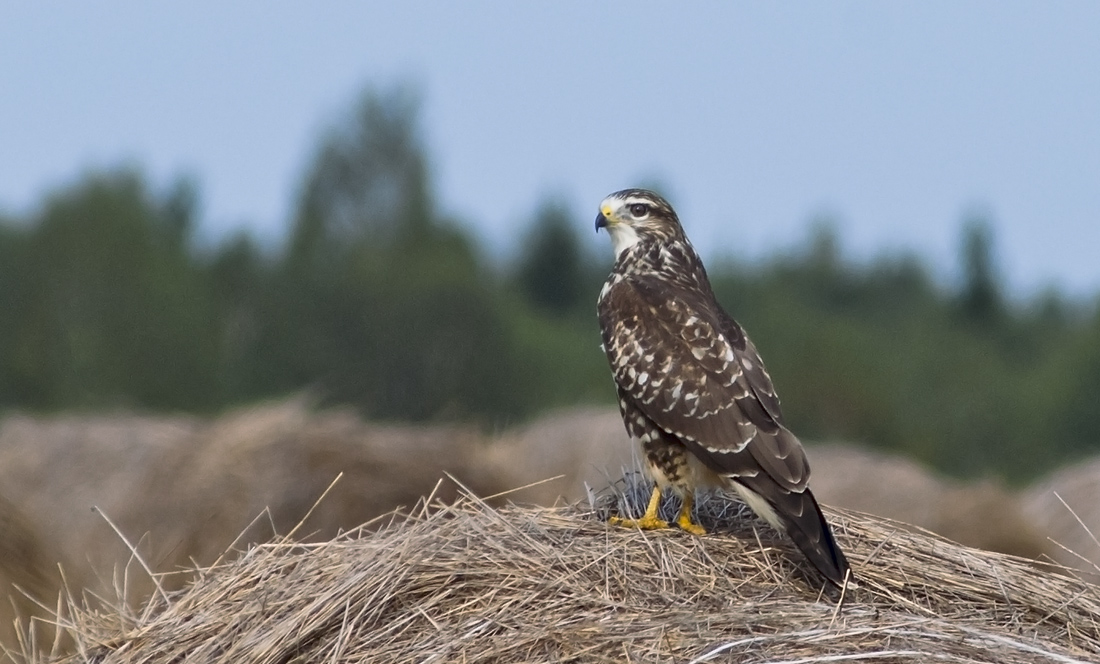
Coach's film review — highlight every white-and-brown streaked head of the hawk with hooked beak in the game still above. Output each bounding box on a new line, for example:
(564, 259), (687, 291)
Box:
(596, 189), (683, 257)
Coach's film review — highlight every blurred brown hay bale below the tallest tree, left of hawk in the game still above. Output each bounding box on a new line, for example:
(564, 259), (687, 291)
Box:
(159, 400), (499, 565)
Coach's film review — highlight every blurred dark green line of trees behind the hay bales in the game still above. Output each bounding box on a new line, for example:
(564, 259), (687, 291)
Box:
(0, 88), (1100, 480)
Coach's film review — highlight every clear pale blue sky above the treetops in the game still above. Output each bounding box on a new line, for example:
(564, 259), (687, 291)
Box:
(0, 0), (1100, 294)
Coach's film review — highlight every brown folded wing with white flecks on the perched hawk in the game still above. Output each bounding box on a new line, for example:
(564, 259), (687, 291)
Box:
(600, 269), (809, 492)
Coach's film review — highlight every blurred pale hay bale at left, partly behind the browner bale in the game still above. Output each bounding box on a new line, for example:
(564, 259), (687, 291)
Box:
(0, 414), (199, 604)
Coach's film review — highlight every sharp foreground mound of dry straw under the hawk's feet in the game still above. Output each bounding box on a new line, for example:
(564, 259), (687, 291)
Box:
(24, 485), (1100, 664)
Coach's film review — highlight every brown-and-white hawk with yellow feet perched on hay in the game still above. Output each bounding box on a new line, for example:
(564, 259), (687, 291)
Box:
(596, 189), (850, 586)
